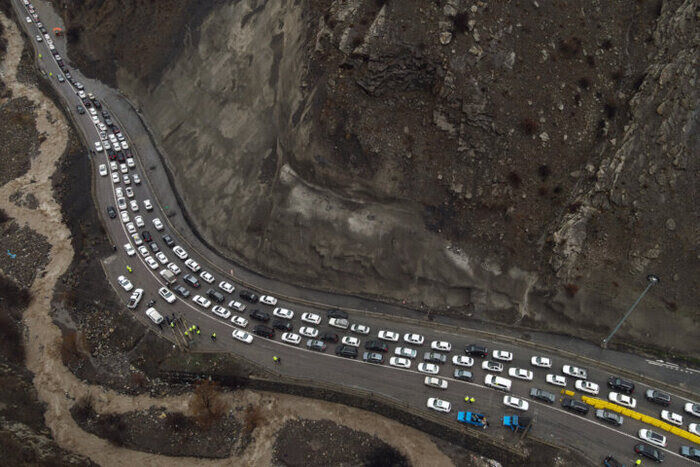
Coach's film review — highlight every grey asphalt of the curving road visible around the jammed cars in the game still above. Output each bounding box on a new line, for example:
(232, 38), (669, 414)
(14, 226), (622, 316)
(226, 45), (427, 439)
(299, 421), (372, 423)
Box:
(13, 0), (700, 465)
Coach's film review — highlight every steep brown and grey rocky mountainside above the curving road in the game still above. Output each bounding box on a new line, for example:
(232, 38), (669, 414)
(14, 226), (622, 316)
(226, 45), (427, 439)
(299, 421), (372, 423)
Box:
(59, 0), (700, 353)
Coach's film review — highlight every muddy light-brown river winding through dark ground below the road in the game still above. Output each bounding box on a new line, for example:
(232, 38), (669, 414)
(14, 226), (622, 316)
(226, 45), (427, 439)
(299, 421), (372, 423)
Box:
(0, 13), (452, 466)
